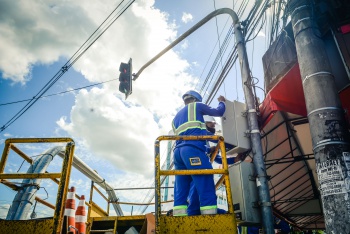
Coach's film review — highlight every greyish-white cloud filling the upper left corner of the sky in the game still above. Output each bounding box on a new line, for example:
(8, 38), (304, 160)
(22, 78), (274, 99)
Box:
(0, 0), (96, 83)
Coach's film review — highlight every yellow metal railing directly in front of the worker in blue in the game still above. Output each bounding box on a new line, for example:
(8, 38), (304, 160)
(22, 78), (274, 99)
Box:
(155, 135), (236, 233)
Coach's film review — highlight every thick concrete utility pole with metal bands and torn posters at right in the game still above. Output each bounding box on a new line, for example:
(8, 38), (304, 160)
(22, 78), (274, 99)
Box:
(287, 0), (350, 234)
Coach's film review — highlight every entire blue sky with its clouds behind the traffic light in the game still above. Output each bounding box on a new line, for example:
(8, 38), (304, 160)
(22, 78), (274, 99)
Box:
(0, 0), (266, 218)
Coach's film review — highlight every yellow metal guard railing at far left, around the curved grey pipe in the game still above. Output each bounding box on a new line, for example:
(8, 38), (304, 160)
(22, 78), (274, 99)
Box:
(0, 138), (75, 233)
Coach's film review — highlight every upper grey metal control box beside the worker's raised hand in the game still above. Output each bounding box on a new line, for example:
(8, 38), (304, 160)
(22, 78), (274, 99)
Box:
(220, 100), (250, 154)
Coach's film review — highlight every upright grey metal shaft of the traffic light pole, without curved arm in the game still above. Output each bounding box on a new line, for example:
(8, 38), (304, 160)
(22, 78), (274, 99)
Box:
(234, 16), (275, 234)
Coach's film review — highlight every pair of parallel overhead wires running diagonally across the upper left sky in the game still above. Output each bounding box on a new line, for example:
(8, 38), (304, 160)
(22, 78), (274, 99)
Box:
(0, 0), (135, 132)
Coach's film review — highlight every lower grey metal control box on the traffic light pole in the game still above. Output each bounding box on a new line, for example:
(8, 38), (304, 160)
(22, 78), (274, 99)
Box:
(229, 162), (261, 225)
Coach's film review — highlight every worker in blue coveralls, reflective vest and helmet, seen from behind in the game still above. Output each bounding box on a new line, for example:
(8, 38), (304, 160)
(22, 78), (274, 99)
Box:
(173, 90), (226, 216)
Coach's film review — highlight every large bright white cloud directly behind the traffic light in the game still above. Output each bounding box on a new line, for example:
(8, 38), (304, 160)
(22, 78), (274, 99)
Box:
(53, 0), (198, 175)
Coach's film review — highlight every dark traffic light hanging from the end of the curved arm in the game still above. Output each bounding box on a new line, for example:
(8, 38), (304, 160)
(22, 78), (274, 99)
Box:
(119, 58), (132, 99)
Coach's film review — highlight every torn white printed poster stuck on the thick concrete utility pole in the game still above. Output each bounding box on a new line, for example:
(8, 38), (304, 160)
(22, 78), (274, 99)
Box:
(316, 159), (347, 196)
